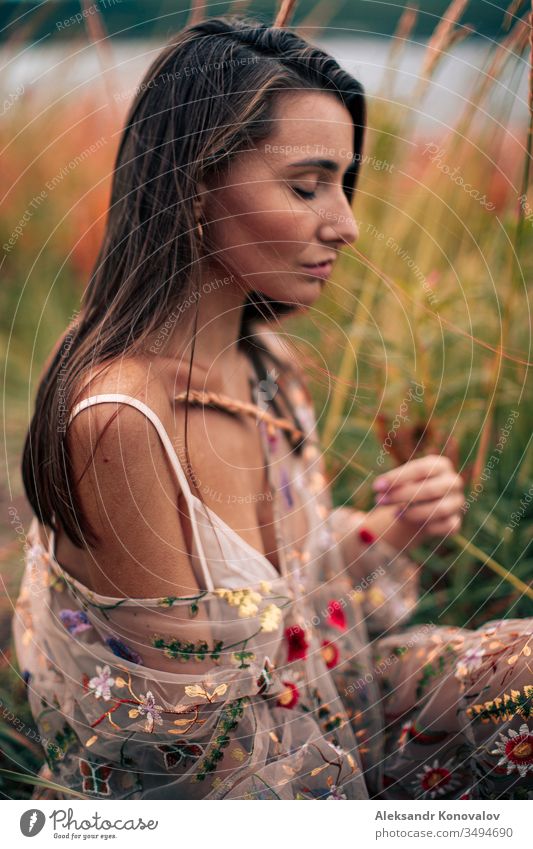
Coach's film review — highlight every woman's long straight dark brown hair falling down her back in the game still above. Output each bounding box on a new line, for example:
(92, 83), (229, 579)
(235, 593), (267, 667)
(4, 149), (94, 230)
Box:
(22, 15), (365, 547)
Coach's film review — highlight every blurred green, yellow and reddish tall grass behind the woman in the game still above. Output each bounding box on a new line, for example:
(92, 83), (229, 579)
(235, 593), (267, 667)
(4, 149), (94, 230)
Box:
(0, 0), (533, 798)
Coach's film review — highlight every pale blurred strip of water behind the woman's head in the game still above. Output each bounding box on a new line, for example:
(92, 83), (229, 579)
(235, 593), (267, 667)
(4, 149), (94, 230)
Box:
(0, 37), (528, 130)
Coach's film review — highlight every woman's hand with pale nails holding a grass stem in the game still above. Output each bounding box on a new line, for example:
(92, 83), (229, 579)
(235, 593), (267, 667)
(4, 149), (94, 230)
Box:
(372, 454), (465, 539)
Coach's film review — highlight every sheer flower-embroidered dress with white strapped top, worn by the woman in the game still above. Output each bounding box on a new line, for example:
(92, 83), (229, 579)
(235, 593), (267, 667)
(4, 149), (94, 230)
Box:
(13, 362), (533, 800)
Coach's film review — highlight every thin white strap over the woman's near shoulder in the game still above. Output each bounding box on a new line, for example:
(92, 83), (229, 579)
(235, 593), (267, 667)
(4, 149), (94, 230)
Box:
(67, 392), (214, 592)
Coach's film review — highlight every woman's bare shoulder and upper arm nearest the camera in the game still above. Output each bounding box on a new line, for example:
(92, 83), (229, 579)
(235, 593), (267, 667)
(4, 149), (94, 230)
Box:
(67, 360), (200, 597)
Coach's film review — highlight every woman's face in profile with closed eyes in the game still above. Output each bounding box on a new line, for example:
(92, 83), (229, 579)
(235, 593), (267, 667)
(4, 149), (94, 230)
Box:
(201, 91), (358, 306)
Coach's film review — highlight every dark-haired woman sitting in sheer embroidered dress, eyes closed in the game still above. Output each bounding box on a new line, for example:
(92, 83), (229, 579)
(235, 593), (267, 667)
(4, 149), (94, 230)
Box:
(14, 17), (533, 799)
